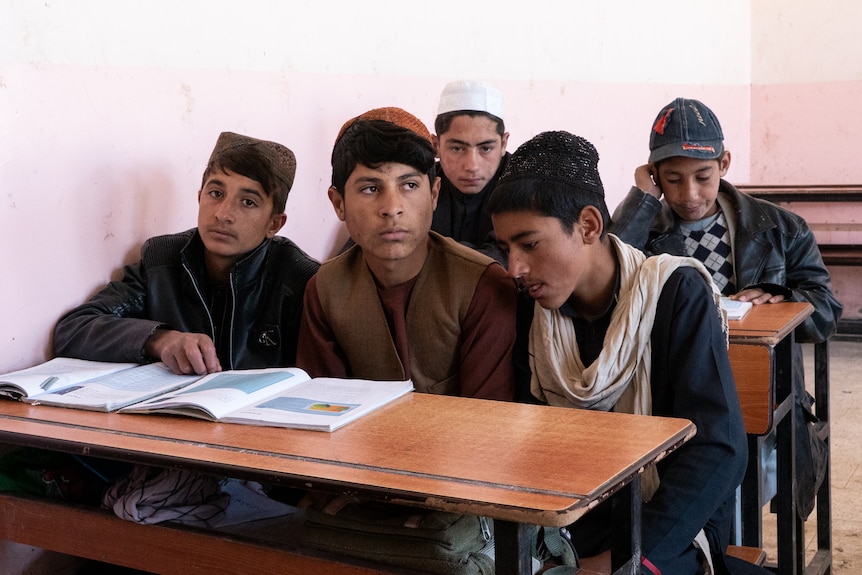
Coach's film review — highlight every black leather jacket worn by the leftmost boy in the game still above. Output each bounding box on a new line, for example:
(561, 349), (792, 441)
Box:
(54, 229), (319, 369)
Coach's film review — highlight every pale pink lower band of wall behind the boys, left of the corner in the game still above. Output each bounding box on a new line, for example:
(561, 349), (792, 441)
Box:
(0, 70), (749, 373)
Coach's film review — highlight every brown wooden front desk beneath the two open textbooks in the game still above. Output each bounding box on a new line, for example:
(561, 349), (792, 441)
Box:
(0, 394), (695, 574)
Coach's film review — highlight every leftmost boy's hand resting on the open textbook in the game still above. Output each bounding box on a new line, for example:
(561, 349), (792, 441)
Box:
(144, 329), (221, 375)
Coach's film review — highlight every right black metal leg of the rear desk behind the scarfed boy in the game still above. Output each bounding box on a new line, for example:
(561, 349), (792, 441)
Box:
(775, 334), (805, 575)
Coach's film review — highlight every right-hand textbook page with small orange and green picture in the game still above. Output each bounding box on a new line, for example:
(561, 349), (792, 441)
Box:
(222, 377), (413, 431)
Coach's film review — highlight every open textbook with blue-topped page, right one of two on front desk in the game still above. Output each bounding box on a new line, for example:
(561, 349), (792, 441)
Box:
(120, 367), (413, 431)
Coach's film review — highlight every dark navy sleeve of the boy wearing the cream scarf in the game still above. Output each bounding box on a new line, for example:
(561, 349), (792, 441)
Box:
(643, 268), (747, 573)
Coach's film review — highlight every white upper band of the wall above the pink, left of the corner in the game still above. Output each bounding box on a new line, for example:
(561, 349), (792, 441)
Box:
(0, 0), (750, 82)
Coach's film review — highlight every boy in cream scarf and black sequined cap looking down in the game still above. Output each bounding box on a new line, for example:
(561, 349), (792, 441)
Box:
(489, 132), (763, 575)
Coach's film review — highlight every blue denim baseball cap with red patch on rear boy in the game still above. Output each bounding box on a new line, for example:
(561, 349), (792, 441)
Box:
(649, 98), (724, 163)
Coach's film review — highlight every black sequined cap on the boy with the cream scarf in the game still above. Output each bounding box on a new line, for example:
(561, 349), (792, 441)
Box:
(498, 131), (605, 197)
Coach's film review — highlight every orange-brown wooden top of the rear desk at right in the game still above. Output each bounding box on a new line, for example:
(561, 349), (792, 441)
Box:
(727, 302), (814, 346)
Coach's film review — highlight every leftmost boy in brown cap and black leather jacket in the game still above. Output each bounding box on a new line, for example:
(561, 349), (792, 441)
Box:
(54, 132), (318, 374)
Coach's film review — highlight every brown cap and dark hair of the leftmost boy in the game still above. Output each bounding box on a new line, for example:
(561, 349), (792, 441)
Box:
(201, 132), (296, 215)
